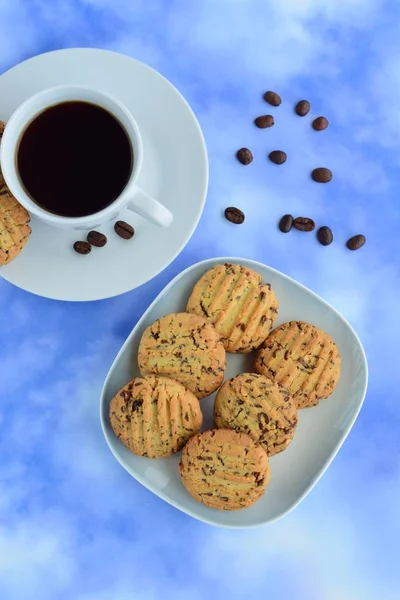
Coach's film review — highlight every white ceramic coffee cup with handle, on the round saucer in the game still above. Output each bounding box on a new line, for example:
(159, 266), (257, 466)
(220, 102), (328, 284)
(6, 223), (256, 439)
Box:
(0, 85), (173, 230)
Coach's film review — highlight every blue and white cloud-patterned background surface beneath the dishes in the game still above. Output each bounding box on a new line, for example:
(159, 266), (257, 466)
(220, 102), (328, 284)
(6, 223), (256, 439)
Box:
(0, 0), (400, 600)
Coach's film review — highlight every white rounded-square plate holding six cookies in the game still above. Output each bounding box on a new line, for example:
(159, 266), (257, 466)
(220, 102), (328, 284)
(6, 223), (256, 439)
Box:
(100, 258), (368, 528)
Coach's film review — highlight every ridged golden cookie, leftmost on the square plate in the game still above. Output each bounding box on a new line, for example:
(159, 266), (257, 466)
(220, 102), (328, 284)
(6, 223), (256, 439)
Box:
(110, 375), (203, 458)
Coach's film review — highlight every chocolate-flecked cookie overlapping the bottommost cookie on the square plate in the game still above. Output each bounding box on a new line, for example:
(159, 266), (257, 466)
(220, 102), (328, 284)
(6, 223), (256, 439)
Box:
(214, 373), (297, 456)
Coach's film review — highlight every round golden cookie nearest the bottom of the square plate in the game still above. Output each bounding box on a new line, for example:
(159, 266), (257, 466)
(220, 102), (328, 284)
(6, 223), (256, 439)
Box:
(179, 429), (270, 510)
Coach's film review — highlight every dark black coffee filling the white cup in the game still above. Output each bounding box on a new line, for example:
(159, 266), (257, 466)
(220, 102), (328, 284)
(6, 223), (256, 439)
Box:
(16, 102), (133, 217)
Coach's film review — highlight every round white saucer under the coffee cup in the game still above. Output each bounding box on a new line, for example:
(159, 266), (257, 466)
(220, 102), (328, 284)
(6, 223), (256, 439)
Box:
(0, 48), (208, 301)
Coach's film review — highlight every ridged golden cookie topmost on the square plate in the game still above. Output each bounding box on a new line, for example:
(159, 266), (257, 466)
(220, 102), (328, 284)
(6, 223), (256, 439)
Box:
(187, 263), (278, 353)
